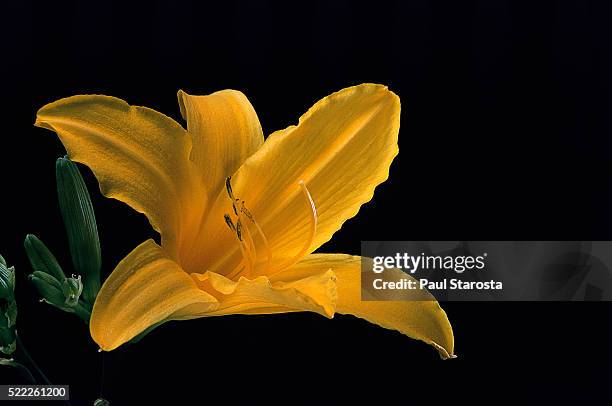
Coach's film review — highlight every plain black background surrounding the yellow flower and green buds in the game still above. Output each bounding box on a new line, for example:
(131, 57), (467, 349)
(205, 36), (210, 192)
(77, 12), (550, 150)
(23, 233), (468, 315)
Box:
(0, 0), (612, 405)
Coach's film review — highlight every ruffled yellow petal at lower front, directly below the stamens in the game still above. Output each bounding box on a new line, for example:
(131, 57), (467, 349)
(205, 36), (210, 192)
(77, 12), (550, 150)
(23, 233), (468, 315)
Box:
(191, 270), (336, 318)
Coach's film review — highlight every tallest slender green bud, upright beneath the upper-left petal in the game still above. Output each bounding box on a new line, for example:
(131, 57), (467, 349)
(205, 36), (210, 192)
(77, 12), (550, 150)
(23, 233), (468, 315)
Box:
(55, 157), (101, 304)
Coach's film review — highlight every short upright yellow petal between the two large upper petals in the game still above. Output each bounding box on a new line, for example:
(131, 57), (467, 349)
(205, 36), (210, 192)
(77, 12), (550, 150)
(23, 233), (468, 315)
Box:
(178, 90), (263, 202)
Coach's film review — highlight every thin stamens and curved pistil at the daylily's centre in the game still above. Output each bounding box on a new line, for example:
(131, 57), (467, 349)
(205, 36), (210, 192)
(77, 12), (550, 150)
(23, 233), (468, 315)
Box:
(223, 177), (318, 278)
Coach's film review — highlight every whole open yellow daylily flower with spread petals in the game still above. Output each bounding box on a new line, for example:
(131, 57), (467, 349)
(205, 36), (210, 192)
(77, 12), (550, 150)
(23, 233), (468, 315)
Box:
(35, 84), (454, 358)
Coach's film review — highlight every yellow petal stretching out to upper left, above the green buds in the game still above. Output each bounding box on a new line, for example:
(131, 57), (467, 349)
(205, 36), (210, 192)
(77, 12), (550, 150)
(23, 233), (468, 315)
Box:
(35, 95), (204, 255)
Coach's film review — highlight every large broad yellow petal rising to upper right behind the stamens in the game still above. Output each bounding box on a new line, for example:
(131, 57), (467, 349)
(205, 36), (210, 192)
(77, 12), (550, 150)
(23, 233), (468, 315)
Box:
(185, 84), (400, 273)
